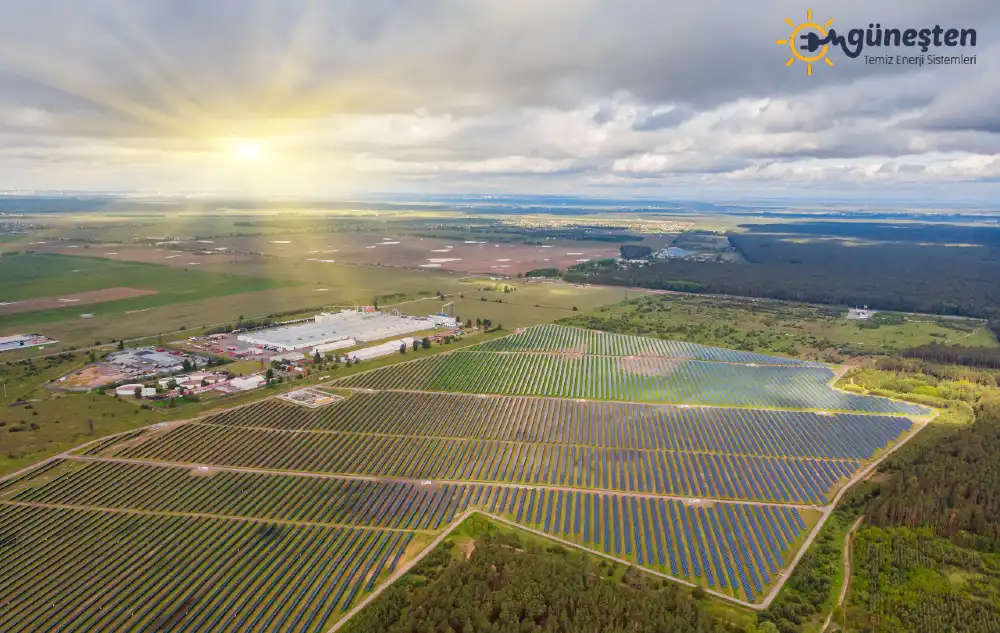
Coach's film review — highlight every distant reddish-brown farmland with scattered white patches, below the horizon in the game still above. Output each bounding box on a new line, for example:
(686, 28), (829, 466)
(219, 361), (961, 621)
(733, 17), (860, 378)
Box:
(24, 216), (648, 277)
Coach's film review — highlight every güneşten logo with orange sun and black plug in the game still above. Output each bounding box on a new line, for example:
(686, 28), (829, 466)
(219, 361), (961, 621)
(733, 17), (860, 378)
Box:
(775, 9), (976, 76)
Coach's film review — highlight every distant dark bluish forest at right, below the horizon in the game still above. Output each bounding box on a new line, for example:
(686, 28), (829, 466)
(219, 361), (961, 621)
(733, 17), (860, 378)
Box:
(565, 222), (1000, 331)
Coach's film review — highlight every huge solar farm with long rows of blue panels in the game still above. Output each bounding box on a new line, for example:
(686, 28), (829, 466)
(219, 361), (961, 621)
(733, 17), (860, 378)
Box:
(0, 325), (931, 633)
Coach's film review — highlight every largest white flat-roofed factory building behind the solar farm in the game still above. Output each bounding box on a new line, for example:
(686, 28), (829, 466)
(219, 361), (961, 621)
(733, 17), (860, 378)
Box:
(238, 307), (455, 353)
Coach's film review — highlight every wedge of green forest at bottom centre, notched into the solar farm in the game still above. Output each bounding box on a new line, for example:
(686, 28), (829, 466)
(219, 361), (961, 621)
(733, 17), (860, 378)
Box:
(342, 517), (730, 633)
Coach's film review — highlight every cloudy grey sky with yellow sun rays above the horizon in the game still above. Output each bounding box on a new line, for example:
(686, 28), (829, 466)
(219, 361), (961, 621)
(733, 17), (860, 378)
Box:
(0, 0), (1000, 201)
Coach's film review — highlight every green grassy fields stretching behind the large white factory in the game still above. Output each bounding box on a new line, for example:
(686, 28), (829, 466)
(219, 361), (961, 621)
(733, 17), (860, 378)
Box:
(0, 255), (623, 360)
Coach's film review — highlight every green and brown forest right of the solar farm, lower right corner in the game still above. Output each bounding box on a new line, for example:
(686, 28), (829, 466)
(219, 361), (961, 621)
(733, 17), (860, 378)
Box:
(838, 359), (1000, 633)
